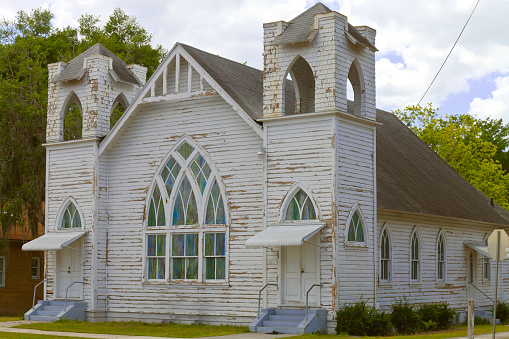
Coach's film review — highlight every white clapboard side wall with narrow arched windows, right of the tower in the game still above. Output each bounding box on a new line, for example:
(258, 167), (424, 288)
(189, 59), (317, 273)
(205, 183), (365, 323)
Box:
(377, 210), (509, 311)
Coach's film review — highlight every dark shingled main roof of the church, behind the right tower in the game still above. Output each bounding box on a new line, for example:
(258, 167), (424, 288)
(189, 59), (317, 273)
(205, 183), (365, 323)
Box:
(180, 44), (509, 225)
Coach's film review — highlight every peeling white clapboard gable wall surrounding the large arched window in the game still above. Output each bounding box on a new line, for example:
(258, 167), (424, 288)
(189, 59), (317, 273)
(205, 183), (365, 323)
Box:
(101, 92), (263, 323)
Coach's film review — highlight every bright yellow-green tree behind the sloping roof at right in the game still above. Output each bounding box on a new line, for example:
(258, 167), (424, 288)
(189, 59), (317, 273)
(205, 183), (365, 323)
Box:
(393, 104), (509, 209)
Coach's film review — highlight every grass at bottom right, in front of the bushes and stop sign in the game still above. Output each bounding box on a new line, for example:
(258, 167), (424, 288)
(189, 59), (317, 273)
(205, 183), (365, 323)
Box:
(303, 325), (509, 339)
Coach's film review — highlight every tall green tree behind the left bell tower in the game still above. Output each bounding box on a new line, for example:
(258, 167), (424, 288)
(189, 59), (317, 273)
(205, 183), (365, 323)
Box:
(0, 8), (166, 244)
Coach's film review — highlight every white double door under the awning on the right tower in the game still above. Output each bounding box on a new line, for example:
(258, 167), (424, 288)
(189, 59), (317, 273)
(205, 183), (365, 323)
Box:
(282, 236), (320, 305)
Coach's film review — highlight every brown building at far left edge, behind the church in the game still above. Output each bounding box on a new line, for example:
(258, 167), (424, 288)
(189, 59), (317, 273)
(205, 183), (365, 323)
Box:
(0, 225), (44, 316)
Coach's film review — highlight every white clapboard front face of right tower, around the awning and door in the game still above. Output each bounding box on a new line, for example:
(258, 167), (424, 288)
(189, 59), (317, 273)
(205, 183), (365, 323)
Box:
(264, 116), (335, 318)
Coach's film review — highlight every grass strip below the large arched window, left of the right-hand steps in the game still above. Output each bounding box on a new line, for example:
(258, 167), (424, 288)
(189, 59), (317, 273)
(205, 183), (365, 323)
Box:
(16, 320), (249, 338)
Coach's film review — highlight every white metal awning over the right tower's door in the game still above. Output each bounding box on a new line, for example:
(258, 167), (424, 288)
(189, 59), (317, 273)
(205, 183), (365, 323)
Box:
(246, 223), (325, 248)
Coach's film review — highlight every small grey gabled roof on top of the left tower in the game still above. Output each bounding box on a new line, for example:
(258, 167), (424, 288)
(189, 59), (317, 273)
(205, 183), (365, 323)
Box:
(51, 43), (142, 85)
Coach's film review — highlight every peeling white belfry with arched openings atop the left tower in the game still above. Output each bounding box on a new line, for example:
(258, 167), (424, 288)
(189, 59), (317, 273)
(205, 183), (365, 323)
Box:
(46, 43), (147, 142)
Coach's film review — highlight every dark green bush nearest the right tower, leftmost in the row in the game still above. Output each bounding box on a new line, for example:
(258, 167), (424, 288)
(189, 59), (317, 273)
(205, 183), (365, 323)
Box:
(336, 301), (392, 336)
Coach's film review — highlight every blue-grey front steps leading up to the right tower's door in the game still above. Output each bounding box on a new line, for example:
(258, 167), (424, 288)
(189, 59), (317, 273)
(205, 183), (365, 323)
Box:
(249, 308), (327, 334)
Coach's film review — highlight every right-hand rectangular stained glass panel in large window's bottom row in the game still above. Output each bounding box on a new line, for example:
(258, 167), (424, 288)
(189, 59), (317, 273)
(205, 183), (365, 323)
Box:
(205, 233), (226, 280)
